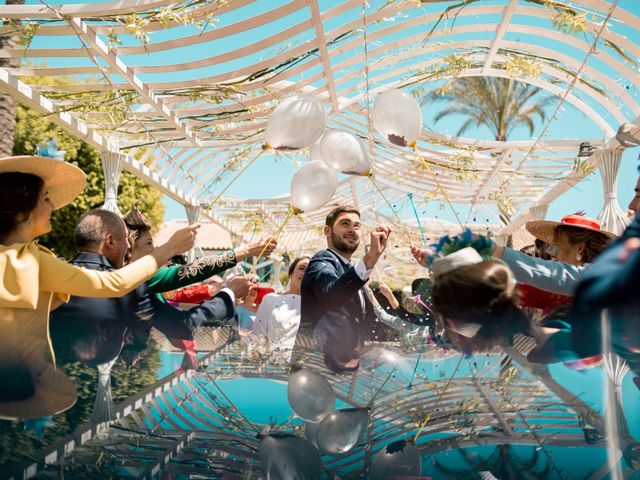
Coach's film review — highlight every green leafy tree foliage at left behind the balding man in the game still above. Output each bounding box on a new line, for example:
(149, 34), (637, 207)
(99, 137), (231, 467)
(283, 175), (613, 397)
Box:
(13, 101), (164, 259)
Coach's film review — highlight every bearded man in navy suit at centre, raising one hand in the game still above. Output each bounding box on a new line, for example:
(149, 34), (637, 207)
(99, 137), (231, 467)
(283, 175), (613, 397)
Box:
(300, 206), (391, 372)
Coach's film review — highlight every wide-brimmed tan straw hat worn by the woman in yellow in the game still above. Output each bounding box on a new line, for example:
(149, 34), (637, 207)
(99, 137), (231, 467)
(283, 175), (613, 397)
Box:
(0, 155), (86, 210)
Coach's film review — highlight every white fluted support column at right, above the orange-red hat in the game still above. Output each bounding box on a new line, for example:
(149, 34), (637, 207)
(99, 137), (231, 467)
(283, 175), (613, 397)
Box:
(596, 148), (629, 235)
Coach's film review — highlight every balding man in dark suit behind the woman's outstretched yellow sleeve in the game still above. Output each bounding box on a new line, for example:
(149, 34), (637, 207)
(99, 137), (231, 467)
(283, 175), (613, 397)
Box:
(50, 209), (250, 365)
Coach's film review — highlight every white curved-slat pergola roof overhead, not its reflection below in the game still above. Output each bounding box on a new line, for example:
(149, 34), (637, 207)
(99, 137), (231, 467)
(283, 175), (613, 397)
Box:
(0, 0), (640, 242)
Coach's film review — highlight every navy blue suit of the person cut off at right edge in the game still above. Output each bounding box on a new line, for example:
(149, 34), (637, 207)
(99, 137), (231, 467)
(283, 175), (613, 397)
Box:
(569, 215), (640, 375)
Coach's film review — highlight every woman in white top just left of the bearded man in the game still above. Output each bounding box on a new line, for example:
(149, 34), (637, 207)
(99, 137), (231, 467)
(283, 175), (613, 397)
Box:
(252, 257), (309, 360)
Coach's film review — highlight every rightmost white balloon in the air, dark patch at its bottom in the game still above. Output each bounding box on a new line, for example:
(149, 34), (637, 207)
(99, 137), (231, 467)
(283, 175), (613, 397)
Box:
(373, 89), (422, 147)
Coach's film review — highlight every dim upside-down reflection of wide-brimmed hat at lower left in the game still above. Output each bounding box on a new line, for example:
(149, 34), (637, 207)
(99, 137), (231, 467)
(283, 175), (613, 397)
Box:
(0, 362), (78, 420)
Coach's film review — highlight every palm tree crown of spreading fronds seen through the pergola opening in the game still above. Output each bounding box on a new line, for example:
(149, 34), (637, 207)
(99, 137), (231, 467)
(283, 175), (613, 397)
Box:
(421, 77), (555, 141)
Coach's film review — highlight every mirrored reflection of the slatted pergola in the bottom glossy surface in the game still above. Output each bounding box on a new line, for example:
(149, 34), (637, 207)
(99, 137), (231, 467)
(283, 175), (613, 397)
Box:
(21, 346), (636, 478)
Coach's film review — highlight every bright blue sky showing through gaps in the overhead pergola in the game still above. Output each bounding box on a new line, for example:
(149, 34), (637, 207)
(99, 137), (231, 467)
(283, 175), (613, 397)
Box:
(16, 0), (640, 227)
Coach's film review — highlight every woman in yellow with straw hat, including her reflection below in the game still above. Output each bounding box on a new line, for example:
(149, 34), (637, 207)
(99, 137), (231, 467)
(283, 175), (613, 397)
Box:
(0, 152), (198, 419)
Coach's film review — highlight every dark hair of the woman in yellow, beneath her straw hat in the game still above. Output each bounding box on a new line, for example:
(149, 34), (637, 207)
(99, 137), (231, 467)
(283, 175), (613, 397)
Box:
(0, 172), (44, 240)
